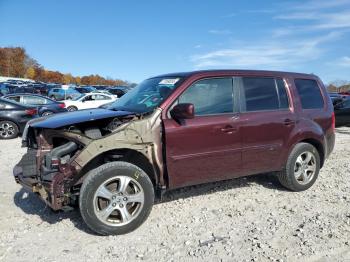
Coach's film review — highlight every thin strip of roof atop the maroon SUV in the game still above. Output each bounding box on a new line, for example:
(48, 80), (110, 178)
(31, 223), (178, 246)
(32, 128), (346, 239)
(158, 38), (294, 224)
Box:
(151, 69), (317, 78)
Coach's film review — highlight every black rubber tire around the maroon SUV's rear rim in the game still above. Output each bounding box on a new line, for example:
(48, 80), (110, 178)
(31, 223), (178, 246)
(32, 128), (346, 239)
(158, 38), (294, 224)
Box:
(277, 143), (321, 191)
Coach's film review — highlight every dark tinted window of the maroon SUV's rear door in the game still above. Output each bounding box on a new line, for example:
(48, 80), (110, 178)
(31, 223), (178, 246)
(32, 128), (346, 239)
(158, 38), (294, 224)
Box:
(242, 77), (289, 112)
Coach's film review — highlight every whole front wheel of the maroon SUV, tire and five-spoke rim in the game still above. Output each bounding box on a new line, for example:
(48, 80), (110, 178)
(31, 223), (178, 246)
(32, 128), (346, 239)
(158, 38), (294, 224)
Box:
(79, 161), (154, 235)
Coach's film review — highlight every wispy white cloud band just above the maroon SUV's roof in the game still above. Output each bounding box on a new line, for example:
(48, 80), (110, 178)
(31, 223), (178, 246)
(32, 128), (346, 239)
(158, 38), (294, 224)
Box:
(191, 32), (340, 68)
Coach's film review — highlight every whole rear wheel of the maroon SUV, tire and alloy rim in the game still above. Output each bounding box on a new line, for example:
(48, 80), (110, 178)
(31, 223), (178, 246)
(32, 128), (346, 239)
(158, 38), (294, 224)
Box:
(277, 143), (321, 191)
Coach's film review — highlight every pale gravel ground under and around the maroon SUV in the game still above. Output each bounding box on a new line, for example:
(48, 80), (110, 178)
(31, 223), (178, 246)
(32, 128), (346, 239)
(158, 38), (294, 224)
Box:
(0, 128), (350, 261)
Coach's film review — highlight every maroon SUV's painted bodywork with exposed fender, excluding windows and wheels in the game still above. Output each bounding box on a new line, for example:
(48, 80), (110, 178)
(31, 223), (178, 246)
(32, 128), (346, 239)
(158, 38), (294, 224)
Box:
(14, 70), (335, 209)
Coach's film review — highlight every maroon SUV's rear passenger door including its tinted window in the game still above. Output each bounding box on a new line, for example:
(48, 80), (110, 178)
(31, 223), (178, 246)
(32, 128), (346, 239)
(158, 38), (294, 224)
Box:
(237, 77), (296, 174)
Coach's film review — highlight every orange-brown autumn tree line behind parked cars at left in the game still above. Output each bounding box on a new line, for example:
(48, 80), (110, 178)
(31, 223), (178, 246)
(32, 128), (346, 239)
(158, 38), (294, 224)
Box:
(0, 47), (130, 86)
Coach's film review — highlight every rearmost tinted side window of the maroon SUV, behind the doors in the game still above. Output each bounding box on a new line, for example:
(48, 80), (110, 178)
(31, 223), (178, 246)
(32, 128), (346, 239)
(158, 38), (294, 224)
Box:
(294, 79), (324, 109)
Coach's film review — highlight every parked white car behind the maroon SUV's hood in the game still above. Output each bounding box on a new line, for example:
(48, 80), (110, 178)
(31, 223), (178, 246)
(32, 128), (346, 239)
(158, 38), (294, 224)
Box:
(63, 93), (118, 111)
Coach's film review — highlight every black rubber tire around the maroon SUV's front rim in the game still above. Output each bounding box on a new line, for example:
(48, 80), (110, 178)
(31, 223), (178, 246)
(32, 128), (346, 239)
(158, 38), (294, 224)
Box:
(79, 161), (154, 235)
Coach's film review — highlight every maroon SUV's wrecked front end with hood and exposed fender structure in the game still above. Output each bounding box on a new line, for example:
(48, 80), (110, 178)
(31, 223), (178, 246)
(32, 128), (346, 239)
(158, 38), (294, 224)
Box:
(13, 109), (162, 210)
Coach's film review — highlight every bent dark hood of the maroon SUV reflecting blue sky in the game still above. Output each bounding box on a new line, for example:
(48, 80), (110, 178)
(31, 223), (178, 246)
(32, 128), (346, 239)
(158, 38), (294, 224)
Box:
(28, 109), (134, 129)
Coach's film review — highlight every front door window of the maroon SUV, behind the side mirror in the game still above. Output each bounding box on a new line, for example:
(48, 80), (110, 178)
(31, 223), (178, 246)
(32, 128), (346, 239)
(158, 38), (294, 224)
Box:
(179, 78), (233, 115)
